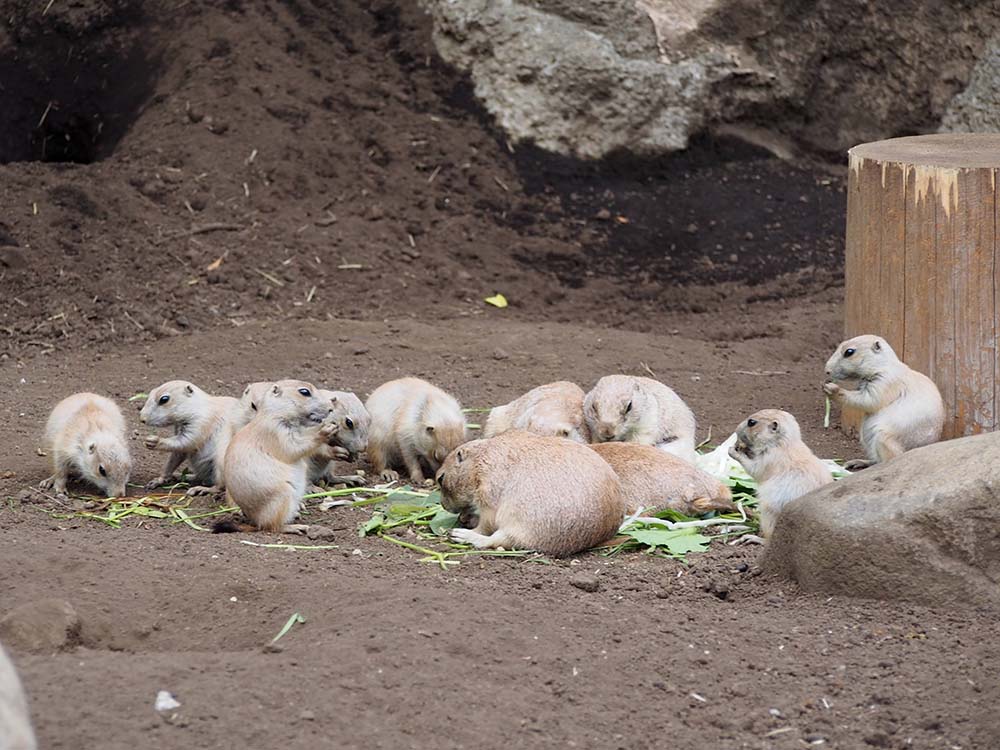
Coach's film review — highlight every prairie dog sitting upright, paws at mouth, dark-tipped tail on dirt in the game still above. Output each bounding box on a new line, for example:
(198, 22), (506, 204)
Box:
(213, 380), (338, 533)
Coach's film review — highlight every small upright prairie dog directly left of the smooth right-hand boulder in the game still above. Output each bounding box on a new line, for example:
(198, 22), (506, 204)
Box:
(729, 409), (833, 538)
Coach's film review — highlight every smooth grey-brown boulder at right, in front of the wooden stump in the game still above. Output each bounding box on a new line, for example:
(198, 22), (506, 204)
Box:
(764, 433), (1000, 607)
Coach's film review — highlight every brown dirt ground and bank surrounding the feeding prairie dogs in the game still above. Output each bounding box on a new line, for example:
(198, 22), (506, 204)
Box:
(0, 0), (1000, 748)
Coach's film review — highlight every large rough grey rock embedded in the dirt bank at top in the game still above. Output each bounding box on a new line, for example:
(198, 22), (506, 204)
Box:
(421, 0), (1000, 158)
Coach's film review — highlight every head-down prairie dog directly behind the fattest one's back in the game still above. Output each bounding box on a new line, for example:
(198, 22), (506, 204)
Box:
(483, 380), (590, 444)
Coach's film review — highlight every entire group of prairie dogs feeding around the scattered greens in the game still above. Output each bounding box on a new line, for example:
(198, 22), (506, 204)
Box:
(42, 336), (944, 555)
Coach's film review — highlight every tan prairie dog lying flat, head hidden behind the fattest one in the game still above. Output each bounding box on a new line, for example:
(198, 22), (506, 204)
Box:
(590, 443), (736, 516)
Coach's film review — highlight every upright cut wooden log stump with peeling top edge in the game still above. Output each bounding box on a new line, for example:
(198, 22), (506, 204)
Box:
(842, 134), (1000, 438)
